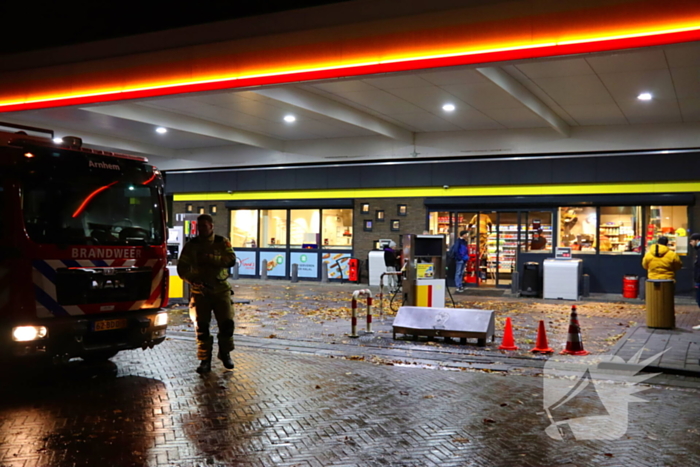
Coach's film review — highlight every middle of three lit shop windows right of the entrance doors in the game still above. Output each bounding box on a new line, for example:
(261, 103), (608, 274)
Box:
(598, 206), (642, 254)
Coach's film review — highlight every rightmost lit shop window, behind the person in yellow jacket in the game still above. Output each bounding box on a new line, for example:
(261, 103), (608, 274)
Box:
(643, 206), (688, 254)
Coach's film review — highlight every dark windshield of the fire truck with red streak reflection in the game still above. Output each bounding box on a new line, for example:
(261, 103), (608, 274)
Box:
(22, 152), (164, 245)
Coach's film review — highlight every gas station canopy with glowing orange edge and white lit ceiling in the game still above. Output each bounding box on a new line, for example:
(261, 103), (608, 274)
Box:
(0, 0), (700, 170)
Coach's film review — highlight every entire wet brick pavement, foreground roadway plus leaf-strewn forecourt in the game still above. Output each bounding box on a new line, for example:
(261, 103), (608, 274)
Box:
(0, 283), (700, 467)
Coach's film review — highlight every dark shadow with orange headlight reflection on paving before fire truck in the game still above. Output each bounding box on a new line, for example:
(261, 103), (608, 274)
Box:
(0, 362), (167, 467)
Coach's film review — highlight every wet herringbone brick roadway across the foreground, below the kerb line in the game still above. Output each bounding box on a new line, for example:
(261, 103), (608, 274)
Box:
(0, 339), (700, 467)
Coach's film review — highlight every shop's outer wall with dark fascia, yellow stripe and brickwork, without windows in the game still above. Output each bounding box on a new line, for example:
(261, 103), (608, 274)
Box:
(166, 150), (700, 293)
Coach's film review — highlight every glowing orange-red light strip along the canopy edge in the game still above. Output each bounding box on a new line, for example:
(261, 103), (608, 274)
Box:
(0, 22), (700, 112)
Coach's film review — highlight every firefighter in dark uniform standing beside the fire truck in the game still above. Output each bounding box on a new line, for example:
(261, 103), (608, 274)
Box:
(177, 214), (236, 374)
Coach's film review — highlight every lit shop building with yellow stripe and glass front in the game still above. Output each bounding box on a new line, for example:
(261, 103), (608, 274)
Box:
(166, 151), (700, 293)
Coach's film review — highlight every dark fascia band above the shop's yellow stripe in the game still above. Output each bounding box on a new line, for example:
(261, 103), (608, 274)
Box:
(166, 151), (700, 196)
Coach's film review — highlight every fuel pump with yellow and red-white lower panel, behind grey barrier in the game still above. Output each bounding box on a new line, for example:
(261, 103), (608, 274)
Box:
(401, 234), (446, 308)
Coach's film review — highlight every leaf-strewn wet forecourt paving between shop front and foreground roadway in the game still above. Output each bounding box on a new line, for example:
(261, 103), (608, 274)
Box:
(165, 280), (700, 358)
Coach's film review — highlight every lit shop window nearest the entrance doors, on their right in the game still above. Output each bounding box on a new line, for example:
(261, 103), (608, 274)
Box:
(557, 206), (598, 254)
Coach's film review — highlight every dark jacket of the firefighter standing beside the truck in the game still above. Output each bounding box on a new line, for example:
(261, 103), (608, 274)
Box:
(177, 234), (236, 294)
